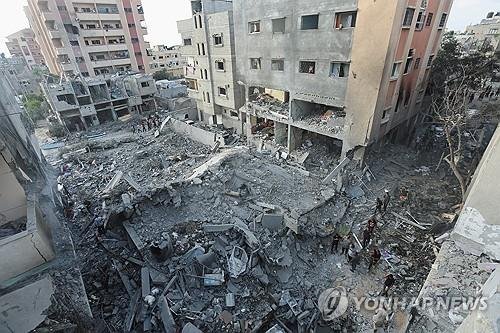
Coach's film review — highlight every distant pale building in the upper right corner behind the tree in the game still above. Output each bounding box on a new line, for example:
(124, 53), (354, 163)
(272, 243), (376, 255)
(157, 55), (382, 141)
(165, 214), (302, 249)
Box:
(459, 12), (500, 53)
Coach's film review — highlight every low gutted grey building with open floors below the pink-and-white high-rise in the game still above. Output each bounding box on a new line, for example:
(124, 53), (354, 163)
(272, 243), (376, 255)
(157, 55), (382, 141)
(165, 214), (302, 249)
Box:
(42, 73), (157, 131)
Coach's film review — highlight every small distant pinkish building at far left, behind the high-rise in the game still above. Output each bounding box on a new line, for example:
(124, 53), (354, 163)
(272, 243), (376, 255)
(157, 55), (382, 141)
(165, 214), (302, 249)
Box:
(5, 29), (45, 69)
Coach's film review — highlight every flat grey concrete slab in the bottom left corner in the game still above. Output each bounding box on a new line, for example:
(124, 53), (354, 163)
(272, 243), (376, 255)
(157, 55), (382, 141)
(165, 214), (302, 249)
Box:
(0, 277), (54, 333)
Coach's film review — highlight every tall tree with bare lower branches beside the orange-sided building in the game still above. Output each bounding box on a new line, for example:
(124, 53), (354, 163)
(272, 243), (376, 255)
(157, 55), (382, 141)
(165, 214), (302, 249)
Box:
(429, 34), (494, 203)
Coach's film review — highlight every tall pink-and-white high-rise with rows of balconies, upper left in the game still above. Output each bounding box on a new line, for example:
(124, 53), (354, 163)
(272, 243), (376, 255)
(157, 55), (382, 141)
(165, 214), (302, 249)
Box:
(25, 0), (150, 77)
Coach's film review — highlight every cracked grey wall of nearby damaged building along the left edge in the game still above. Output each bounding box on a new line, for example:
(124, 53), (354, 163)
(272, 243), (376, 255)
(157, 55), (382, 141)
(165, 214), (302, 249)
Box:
(0, 69), (91, 332)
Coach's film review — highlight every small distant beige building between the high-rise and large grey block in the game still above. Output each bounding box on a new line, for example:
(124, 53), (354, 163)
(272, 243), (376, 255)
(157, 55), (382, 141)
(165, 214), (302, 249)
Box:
(149, 45), (187, 77)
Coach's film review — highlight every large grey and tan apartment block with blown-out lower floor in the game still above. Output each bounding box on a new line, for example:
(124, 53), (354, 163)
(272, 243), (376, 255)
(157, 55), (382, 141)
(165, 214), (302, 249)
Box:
(178, 0), (452, 155)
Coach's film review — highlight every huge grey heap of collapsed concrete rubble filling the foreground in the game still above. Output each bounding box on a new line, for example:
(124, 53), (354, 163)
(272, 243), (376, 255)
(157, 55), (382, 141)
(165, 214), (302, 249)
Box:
(47, 120), (456, 332)
